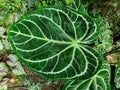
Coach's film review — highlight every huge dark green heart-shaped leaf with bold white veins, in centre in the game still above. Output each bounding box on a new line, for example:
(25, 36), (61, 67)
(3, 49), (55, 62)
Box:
(8, 6), (103, 79)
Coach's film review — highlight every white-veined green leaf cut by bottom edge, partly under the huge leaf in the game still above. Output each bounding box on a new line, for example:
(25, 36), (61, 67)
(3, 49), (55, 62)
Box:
(63, 62), (110, 90)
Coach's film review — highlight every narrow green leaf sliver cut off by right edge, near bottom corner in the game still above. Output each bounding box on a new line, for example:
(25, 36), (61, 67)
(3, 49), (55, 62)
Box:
(114, 64), (120, 88)
